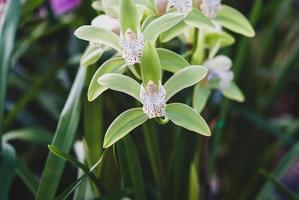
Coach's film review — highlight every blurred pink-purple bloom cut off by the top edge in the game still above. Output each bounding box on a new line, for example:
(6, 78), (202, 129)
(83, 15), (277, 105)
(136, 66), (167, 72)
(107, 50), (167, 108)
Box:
(50, 0), (80, 15)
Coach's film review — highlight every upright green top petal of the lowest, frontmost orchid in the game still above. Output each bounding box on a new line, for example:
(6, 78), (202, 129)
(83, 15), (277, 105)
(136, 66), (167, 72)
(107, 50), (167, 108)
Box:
(140, 41), (162, 85)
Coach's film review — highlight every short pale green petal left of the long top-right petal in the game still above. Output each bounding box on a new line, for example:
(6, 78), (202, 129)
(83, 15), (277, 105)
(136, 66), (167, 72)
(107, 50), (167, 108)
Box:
(184, 9), (214, 29)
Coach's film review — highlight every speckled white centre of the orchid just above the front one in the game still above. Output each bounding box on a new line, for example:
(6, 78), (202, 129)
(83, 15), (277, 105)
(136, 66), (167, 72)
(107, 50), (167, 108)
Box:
(120, 29), (144, 65)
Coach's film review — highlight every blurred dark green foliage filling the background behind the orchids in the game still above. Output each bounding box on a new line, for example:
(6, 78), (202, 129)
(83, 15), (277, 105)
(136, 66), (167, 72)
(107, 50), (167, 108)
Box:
(0, 0), (299, 200)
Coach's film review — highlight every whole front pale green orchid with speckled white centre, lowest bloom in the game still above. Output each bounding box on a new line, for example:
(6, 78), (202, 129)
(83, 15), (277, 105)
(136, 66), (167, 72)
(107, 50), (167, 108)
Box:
(98, 42), (210, 148)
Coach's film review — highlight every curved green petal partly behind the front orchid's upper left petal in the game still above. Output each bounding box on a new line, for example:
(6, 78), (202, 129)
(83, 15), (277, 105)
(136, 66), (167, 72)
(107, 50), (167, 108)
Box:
(87, 58), (126, 101)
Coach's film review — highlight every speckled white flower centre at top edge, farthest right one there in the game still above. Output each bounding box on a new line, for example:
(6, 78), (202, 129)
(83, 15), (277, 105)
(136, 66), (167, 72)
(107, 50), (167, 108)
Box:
(200, 0), (221, 18)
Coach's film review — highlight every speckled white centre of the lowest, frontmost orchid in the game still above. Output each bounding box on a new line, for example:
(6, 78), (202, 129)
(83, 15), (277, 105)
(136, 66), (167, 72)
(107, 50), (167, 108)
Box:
(140, 81), (166, 119)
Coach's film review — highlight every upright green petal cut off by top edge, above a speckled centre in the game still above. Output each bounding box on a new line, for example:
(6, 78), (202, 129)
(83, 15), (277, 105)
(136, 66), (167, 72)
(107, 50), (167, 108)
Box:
(119, 0), (139, 34)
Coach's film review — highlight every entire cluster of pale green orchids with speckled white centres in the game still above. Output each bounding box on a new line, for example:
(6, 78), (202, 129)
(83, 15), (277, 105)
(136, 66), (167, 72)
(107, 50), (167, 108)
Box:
(75, 0), (255, 148)
